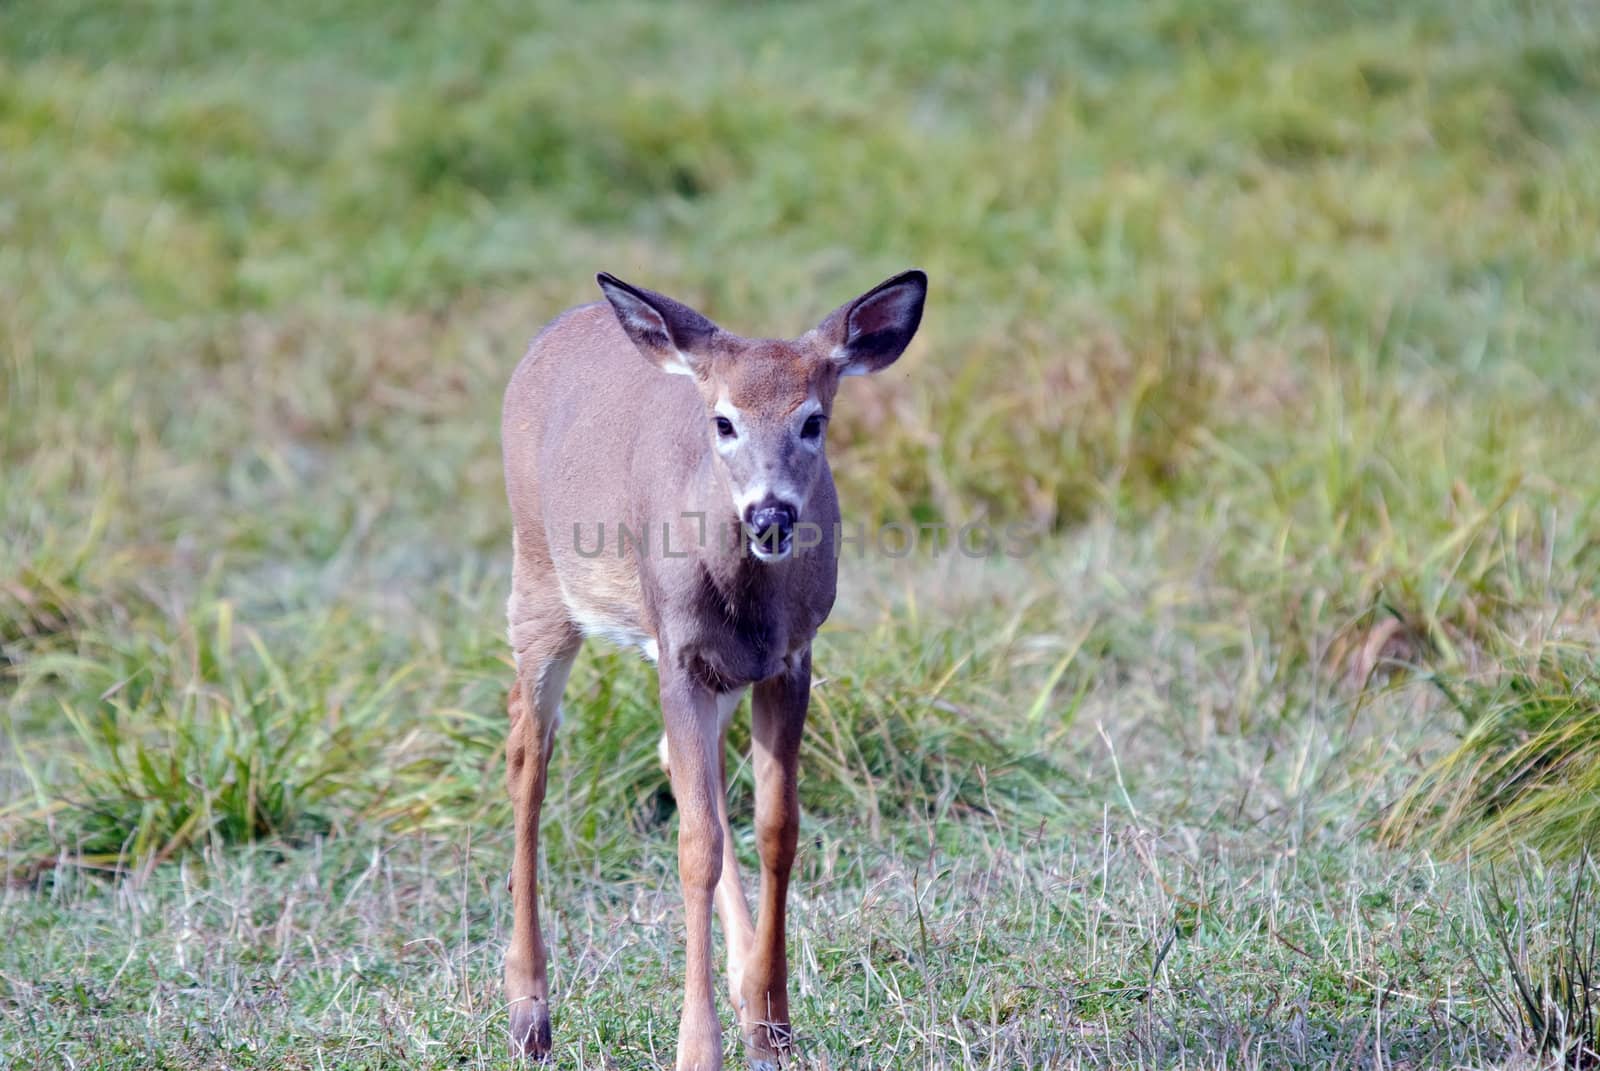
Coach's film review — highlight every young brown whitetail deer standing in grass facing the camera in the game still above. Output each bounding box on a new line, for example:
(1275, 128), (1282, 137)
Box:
(502, 271), (928, 1071)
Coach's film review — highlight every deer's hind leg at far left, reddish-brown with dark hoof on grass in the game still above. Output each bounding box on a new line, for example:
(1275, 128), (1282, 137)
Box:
(506, 596), (582, 1060)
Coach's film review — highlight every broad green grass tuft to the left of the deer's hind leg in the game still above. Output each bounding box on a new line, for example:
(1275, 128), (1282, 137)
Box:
(6, 600), (406, 871)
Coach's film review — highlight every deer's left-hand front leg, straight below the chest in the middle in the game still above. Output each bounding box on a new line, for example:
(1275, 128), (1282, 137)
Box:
(661, 656), (726, 1071)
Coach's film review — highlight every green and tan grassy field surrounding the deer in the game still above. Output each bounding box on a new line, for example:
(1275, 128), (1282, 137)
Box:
(0, 0), (1600, 1069)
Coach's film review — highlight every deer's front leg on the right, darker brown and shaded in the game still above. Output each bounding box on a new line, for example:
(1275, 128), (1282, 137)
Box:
(738, 648), (811, 1068)
